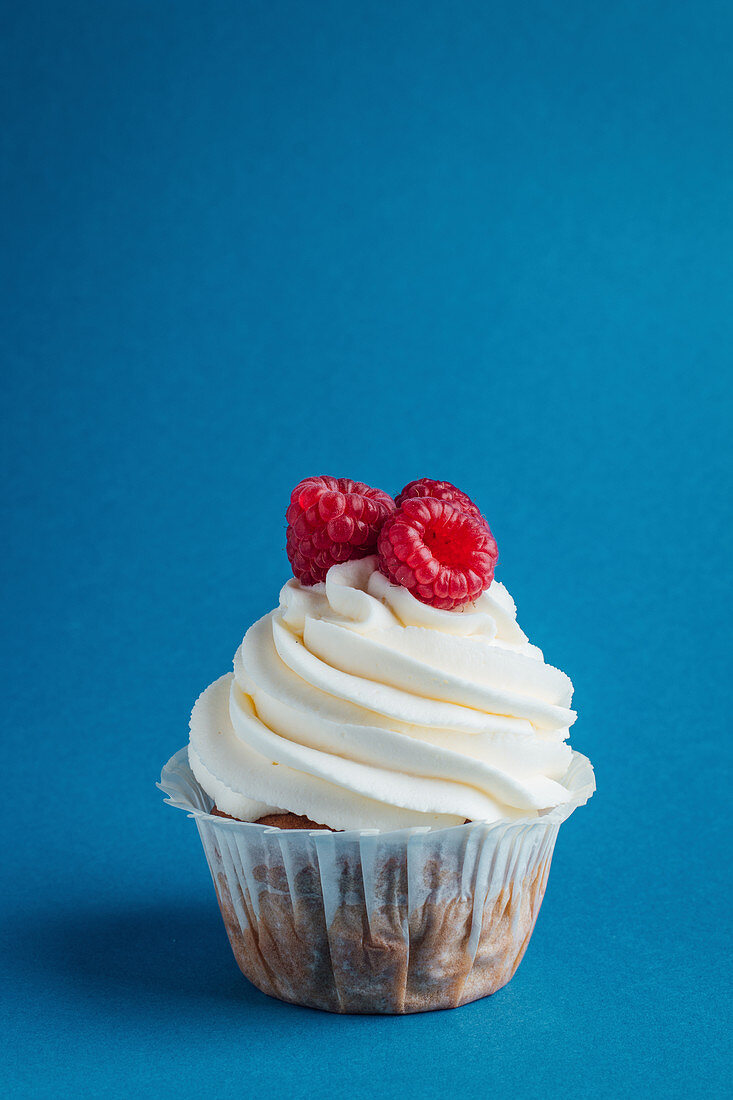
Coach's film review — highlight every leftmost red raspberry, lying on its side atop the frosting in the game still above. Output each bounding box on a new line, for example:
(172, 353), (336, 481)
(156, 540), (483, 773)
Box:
(285, 476), (395, 584)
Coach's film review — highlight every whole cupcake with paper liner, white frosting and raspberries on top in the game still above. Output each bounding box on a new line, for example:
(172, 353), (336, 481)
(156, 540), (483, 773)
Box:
(160, 477), (595, 1013)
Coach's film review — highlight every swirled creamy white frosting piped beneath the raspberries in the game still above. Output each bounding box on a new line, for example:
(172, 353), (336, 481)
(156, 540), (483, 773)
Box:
(189, 558), (576, 829)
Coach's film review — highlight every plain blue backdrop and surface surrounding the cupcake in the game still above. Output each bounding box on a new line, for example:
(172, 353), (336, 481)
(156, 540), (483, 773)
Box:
(0, 0), (733, 1100)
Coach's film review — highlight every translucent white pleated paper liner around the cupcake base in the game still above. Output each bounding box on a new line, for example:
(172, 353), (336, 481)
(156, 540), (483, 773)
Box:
(158, 748), (594, 1013)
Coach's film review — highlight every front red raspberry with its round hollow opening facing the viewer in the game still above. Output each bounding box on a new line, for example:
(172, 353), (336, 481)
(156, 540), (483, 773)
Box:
(378, 496), (497, 611)
